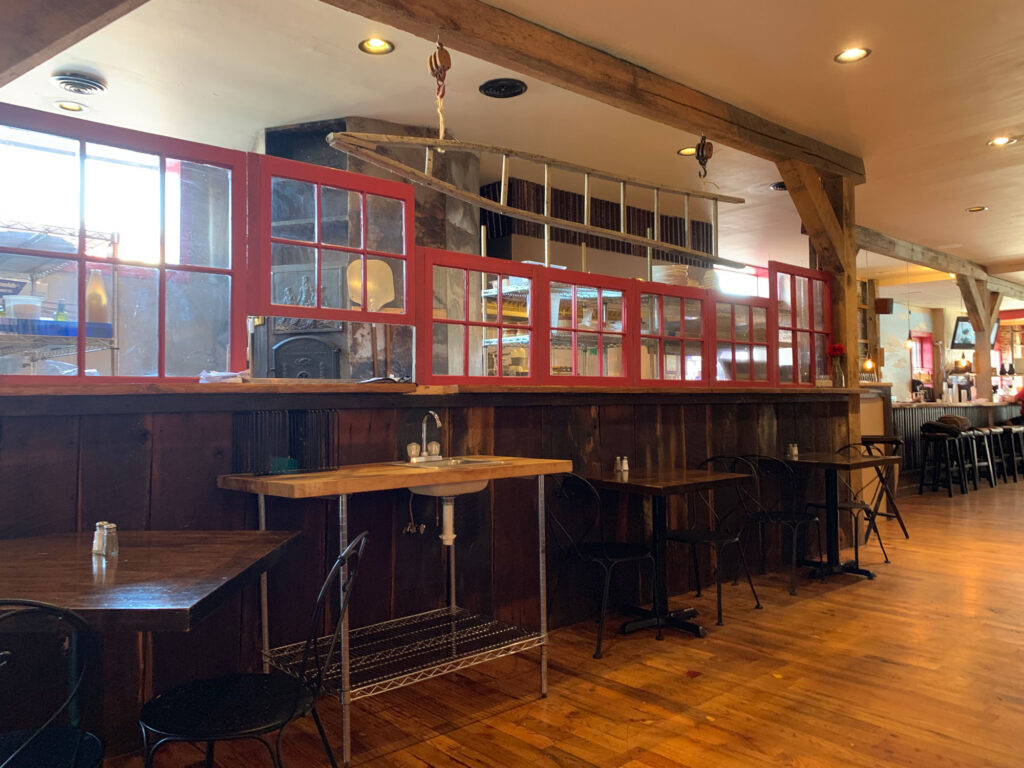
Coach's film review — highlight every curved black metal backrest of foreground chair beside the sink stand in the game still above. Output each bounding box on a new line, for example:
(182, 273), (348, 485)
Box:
(300, 530), (370, 696)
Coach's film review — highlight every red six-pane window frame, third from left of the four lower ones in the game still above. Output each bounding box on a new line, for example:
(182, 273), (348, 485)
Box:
(633, 283), (711, 387)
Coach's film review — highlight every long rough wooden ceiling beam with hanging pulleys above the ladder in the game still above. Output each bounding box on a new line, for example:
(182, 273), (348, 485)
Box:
(322, 0), (864, 183)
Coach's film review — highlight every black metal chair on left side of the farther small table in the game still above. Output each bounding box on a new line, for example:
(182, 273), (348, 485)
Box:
(742, 454), (824, 595)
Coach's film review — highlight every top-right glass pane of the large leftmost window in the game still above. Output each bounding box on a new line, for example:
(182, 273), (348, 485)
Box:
(165, 160), (231, 269)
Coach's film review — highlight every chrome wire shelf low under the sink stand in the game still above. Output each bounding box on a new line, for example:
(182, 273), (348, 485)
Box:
(265, 607), (544, 699)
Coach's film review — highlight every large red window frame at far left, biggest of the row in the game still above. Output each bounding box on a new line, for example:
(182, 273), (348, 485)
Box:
(0, 103), (248, 387)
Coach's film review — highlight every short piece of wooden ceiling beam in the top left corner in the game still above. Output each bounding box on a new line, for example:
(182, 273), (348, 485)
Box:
(0, 0), (145, 86)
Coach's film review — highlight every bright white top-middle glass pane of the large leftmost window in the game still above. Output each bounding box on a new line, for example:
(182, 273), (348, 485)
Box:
(85, 144), (160, 264)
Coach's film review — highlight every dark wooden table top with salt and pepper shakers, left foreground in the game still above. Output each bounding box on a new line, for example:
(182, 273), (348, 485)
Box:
(0, 530), (298, 631)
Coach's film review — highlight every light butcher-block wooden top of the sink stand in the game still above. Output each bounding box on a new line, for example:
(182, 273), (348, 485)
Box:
(217, 456), (572, 499)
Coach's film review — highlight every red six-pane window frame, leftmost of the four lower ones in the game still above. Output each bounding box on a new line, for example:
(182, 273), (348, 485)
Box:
(416, 248), (543, 384)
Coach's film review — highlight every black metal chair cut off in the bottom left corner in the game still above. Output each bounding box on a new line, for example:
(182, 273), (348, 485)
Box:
(0, 598), (103, 768)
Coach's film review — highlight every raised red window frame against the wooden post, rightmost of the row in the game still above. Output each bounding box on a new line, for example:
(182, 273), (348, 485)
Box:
(768, 261), (831, 387)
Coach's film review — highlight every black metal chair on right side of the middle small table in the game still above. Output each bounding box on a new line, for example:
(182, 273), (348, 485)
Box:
(666, 456), (761, 627)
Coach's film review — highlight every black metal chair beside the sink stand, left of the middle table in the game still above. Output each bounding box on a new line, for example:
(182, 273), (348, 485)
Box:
(547, 473), (662, 658)
